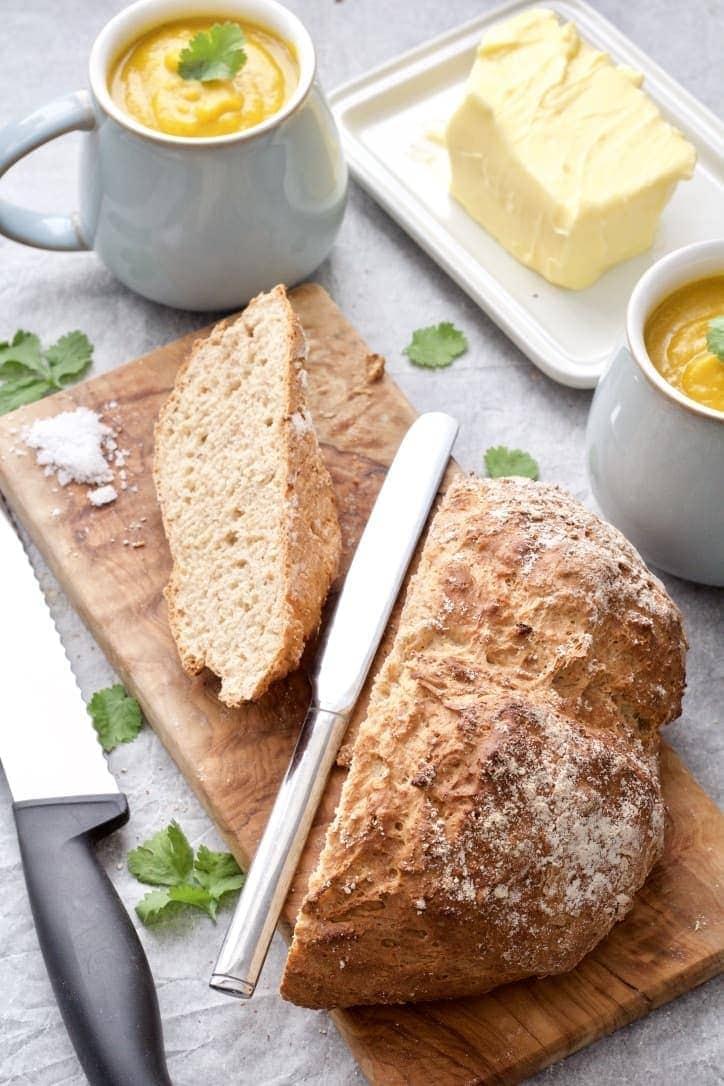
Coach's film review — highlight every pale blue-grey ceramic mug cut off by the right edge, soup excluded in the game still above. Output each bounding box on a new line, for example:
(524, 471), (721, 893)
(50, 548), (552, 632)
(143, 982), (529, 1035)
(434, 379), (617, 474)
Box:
(586, 239), (724, 585)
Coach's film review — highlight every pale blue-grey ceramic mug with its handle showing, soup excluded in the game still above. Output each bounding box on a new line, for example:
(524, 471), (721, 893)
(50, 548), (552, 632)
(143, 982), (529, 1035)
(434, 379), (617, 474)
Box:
(0, 0), (347, 310)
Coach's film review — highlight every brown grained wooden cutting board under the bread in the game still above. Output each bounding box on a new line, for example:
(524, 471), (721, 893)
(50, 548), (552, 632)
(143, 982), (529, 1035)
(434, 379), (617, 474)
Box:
(0, 286), (724, 1086)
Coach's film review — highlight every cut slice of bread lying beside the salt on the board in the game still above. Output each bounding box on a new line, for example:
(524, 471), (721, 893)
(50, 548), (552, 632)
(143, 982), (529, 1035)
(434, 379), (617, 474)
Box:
(154, 287), (341, 705)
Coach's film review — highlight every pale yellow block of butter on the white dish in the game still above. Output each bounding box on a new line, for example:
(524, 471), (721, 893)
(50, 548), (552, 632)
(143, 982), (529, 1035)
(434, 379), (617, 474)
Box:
(445, 8), (696, 289)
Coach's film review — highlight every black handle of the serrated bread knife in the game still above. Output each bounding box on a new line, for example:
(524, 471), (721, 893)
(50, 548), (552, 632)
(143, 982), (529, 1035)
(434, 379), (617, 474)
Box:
(13, 795), (172, 1086)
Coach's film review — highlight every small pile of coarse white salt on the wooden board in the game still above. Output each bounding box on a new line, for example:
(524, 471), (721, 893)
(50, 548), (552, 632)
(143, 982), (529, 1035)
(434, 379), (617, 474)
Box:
(23, 407), (118, 506)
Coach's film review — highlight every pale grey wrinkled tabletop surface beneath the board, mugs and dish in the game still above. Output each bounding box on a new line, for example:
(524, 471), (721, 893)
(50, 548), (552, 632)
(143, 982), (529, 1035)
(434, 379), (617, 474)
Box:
(0, 0), (724, 1086)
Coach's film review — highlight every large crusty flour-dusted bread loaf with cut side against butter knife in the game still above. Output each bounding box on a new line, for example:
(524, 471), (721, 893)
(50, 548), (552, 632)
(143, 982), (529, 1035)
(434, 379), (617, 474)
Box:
(281, 478), (686, 1007)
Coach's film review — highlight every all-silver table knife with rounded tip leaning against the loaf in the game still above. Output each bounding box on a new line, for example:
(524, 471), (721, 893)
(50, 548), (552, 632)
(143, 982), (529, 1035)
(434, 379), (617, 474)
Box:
(211, 412), (458, 999)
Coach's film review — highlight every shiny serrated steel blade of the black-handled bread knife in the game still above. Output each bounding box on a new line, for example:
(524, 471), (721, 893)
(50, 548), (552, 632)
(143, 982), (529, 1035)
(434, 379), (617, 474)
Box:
(0, 498), (118, 803)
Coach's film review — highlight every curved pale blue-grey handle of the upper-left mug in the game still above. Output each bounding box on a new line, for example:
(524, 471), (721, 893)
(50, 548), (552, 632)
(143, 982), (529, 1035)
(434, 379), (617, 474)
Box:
(0, 90), (96, 252)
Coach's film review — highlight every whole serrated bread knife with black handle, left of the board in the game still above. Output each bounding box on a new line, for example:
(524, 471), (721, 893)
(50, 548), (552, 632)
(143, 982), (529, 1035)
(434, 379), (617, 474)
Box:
(0, 500), (170, 1086)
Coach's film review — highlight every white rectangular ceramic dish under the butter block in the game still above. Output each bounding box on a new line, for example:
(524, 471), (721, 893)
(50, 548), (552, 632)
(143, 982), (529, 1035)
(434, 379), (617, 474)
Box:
(330, 0), (724, 388)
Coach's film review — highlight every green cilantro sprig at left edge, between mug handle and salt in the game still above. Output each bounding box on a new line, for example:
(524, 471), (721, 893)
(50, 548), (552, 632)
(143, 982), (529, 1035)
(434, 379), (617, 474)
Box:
(0, 329), (93, 415)
